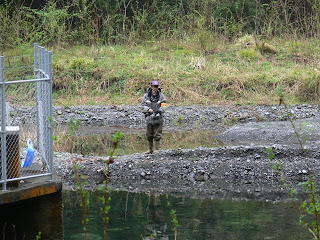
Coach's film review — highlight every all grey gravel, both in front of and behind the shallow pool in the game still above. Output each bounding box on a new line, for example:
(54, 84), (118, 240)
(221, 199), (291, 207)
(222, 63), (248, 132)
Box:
(31, 105), (320, 201)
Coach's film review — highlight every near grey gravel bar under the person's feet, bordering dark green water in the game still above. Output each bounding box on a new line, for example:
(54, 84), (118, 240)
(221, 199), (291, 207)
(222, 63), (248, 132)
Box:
(55, 146), (320, 201)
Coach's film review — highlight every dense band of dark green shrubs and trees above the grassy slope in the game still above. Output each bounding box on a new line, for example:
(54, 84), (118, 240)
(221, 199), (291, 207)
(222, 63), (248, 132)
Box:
(0, 0), (320, 45)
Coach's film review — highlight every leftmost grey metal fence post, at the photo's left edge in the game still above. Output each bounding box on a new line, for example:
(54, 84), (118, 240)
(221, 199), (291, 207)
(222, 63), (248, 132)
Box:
(0, 56), (7, 191)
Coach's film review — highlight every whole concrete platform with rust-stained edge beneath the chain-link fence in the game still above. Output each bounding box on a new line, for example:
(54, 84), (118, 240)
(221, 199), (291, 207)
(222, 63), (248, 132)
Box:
(0, 177), (64, 240)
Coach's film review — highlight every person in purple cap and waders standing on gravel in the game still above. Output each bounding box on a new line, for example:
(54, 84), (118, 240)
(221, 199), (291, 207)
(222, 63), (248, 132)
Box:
(141, 81), (167, 154)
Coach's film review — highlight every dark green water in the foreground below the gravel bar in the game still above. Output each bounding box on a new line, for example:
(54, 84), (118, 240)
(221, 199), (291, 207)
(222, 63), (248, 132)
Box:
(63, 191), (311, 240)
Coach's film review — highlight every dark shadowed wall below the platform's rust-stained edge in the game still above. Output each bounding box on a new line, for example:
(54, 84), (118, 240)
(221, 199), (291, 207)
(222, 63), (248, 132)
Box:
(0, 191), (63, 240)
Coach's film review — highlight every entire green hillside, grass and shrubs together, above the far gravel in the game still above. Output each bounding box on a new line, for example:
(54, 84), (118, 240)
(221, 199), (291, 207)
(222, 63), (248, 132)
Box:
(0, 0), (320, 106)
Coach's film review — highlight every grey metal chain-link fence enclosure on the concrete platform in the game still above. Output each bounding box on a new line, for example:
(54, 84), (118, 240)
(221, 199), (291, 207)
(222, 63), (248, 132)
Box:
(0, 44), (53, 191)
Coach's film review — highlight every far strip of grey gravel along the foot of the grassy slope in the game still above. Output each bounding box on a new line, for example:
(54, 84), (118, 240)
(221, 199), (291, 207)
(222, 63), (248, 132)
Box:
(10, 104), (320, 129)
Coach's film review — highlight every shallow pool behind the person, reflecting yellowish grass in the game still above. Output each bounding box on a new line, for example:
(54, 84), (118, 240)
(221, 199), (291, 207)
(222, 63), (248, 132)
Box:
(54, 129), (223, 156)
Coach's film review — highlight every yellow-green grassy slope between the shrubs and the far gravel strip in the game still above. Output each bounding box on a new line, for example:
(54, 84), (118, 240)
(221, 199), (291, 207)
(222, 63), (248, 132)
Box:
(4, 35), (320, 106)
